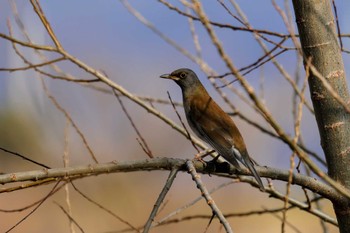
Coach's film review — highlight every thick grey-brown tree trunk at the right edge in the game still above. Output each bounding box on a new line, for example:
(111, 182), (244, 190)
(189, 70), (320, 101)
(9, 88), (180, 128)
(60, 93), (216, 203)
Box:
(293, 0), (350, 233)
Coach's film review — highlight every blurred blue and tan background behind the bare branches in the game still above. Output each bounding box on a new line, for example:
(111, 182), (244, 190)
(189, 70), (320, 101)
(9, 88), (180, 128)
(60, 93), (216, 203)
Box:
(0, 0), (350, 233)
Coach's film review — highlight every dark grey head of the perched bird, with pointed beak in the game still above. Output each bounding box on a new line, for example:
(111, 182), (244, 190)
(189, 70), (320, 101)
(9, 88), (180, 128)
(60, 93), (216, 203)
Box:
(160, 68), (202, 89)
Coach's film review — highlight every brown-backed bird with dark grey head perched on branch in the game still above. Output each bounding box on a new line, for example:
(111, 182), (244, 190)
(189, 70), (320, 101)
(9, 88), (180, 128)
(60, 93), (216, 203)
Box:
(160, 68), (265, 191)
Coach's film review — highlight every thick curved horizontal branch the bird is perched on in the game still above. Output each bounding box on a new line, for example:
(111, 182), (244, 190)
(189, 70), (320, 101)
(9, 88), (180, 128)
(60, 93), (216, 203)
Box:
(0, 158), (348, 204)
